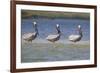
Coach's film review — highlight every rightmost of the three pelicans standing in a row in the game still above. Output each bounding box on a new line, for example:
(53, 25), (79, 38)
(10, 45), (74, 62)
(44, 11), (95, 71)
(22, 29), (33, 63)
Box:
(68, 25), (83, 42)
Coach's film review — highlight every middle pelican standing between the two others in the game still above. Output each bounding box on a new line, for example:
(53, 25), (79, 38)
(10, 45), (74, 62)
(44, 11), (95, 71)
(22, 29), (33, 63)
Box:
(46, 24), (61, 43)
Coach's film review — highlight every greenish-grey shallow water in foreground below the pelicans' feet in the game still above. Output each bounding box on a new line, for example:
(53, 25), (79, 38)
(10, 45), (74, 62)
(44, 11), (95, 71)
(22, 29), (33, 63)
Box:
(21, 42), (90, 63)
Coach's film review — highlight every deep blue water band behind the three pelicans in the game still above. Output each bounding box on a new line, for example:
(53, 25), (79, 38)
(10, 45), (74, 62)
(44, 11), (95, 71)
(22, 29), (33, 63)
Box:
(21, 18), (90, 40)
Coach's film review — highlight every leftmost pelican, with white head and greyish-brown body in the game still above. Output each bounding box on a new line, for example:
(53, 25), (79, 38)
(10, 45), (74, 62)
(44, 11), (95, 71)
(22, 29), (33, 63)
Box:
(22, 22), (39, 42)
